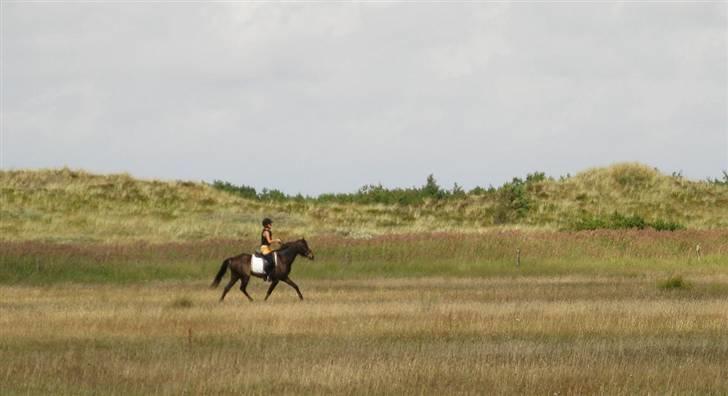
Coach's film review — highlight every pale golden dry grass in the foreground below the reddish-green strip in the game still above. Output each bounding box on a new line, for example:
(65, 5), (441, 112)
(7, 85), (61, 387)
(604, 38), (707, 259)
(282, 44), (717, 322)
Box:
(0, 273), (728, 395)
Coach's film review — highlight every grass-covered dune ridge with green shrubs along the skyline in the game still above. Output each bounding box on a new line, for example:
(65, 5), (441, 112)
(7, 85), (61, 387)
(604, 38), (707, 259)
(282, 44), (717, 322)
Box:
(0, 164), (728, 242)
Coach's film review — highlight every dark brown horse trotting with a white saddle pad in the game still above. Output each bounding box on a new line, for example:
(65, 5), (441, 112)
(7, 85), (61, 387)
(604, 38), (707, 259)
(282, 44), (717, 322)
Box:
(210, 238), (313, 301)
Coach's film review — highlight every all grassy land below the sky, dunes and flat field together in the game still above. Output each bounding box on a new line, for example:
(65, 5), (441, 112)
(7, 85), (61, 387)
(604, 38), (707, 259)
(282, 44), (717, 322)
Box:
(0, 164), (728, 395)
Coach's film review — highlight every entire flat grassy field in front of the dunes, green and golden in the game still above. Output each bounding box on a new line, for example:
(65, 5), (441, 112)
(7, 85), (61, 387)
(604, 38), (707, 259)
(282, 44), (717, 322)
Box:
(0, 230), (728, 395)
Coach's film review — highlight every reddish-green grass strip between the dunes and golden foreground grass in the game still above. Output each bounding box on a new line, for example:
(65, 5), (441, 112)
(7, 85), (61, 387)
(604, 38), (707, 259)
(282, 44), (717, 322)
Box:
(0, 230), (728, 285)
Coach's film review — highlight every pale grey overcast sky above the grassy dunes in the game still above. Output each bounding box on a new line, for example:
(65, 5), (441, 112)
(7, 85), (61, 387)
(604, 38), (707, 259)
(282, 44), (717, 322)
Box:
(0, 1), (728, 195)
